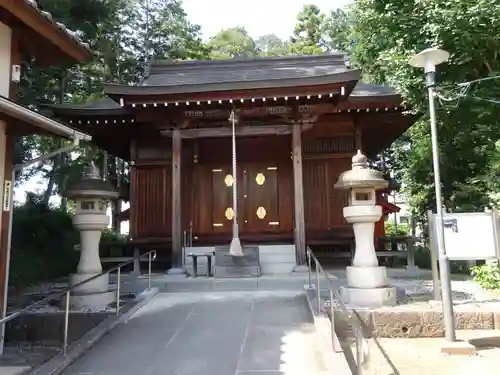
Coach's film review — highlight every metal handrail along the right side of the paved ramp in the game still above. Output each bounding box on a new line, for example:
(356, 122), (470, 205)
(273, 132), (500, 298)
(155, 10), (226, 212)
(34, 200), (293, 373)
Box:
(307, 246), (369, 375)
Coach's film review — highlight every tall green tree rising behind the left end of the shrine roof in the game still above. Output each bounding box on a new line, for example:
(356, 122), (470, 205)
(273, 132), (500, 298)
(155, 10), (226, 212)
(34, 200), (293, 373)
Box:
(15, 0), (208, 206)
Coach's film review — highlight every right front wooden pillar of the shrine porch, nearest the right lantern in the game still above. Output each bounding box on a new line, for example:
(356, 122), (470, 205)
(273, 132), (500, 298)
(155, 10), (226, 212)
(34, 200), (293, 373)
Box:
(292, 124), (306, 266)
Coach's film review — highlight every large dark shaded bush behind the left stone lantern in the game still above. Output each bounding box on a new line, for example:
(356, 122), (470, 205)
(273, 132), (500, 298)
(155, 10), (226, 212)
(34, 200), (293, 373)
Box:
(9, 203), (79, 287)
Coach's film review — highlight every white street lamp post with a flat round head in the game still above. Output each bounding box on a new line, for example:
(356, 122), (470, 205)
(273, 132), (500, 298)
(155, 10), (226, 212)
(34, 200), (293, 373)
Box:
(409, 48), (456, 342)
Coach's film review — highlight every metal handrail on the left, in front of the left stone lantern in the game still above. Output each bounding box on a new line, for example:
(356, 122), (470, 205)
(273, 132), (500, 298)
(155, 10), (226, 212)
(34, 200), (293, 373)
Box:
(0, 250), (156, 355)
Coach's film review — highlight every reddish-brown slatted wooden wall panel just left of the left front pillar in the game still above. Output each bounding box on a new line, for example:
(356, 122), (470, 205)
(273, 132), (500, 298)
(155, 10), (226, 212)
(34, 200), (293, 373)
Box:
(130, 165), (172, 239)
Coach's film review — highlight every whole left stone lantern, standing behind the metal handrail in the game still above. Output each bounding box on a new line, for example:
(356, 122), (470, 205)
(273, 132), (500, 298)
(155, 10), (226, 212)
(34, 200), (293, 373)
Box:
(66, 163), (118, 309)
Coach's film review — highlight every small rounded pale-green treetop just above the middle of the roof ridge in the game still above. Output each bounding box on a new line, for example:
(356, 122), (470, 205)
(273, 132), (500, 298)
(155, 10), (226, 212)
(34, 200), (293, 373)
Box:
(208, 26), (258, 59)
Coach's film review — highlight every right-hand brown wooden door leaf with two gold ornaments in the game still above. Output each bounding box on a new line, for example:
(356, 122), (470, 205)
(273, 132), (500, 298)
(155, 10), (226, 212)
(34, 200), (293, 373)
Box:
(241, 164), (280, 232)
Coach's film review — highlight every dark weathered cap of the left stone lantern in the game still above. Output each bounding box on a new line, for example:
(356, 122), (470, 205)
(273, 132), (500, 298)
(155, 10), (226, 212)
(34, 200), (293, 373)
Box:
(65, 162), (119, 199)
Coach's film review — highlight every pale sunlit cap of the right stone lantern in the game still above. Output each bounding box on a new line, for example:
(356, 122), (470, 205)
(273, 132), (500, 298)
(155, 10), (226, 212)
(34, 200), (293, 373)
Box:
(334, 150), (389, 190)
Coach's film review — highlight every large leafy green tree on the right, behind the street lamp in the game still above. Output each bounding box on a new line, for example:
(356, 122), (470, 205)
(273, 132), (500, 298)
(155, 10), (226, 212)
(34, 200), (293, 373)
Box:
(351, 0), (500, 223)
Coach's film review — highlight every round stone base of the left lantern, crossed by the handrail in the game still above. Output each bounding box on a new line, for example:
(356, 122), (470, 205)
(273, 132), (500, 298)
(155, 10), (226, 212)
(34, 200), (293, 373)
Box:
(69, 273), (116, 310)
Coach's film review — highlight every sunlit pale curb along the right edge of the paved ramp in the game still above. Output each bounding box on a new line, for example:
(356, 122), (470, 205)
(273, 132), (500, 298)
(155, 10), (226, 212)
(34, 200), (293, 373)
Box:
(304, 285), (353, 375)
